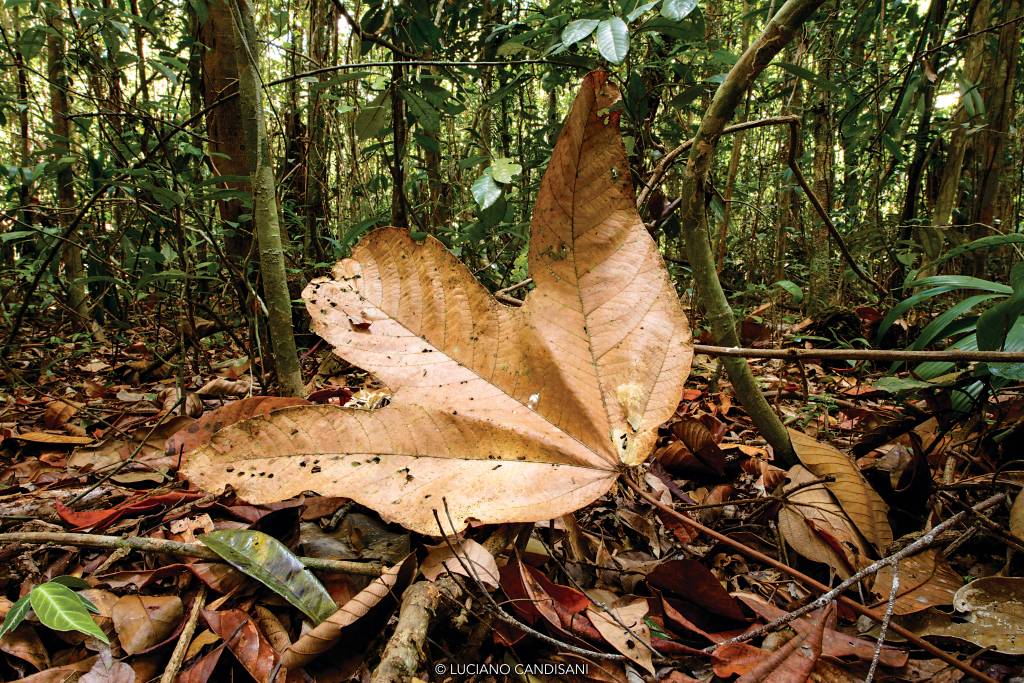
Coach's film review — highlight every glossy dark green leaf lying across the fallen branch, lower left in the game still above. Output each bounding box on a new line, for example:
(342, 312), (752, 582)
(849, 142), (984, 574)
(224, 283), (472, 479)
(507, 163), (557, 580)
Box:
(199, 529), (338, 624)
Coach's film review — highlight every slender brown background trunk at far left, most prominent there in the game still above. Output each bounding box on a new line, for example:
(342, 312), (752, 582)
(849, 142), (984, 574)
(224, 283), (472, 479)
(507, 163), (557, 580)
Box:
(46, 5), (90, 329)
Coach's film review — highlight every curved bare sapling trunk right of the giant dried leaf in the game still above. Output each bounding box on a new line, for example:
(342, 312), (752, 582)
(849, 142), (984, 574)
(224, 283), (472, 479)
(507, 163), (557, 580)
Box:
(681, 0), (824, 466)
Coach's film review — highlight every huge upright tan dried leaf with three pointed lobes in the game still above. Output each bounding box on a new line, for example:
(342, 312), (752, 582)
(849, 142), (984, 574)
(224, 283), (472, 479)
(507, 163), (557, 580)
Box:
(183, 73), (692, 533)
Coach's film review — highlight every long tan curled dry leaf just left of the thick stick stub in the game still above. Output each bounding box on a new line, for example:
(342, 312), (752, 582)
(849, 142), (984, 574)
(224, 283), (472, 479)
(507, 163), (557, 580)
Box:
(282, 555), (416, 669)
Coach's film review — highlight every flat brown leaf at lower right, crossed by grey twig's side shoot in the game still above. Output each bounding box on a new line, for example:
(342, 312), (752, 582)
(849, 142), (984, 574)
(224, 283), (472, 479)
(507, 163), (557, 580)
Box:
(871, 550), (964, 614)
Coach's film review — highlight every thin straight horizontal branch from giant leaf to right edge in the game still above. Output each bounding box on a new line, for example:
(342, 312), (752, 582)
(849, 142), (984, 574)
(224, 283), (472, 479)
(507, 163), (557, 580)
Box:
(693, 344), (1024, 362)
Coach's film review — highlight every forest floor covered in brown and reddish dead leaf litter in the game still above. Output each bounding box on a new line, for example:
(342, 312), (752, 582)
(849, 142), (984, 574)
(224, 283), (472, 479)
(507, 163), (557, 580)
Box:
(0, 311), (1024, 683)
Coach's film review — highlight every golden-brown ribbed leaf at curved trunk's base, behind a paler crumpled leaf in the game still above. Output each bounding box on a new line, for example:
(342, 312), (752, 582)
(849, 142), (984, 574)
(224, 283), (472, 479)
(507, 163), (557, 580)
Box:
(790, 429), (893, 552)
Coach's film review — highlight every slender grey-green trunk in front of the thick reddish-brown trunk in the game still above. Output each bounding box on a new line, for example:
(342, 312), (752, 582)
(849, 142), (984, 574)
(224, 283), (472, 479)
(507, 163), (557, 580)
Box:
(230, 0), (303, 396)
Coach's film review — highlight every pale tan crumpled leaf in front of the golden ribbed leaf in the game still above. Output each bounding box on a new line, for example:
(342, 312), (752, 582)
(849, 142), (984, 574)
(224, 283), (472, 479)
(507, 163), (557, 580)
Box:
(778, 465), (867, 579)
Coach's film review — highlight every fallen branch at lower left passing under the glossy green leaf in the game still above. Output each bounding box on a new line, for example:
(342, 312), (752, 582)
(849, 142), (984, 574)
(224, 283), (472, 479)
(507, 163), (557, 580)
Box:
(0, 531), (381, 577)
